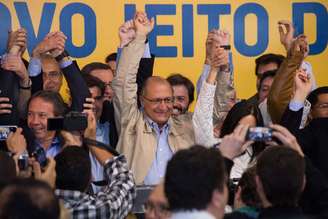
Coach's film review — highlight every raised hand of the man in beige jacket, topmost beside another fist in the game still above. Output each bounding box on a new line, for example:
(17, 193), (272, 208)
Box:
(133, 11), (155, 36)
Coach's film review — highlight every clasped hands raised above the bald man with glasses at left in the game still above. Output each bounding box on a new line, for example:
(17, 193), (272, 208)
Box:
(32, 32), (67, 58)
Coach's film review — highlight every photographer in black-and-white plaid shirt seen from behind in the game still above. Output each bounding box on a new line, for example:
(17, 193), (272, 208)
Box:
(55, 143), (135, 218)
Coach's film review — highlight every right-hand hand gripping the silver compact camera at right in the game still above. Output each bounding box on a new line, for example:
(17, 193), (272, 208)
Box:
(270, 124), (304, 157)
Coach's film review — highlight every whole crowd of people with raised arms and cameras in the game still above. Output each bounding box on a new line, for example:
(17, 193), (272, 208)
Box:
(0, 12), (328, 219)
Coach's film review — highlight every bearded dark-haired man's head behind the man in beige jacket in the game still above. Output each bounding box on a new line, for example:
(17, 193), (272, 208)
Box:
(166, 74), (195, 115)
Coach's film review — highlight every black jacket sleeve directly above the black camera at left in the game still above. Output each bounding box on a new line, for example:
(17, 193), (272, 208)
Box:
(62, 61), (91, 112)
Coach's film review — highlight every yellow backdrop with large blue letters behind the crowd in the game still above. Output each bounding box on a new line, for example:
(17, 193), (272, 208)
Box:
(0, 0), (328, 103)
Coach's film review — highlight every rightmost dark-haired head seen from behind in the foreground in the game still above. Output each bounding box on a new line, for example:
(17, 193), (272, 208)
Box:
(256, 146), (305, 210)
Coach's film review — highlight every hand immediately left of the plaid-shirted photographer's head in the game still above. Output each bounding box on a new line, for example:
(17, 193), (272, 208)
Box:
(32, 157), (56, 189)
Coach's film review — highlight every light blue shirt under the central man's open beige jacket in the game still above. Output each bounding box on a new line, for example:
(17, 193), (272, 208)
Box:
(144, 118), (173, 185)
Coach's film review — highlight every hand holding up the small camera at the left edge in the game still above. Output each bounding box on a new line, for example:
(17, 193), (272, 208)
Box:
(6, 128), (26, 156)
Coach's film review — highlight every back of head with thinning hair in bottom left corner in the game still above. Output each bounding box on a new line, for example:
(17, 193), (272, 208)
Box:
(0, 178), (60, 219)
